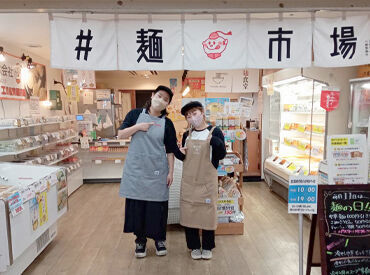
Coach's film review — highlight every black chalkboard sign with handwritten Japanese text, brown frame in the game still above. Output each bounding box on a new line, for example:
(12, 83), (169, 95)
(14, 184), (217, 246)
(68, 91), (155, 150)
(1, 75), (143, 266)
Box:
(318, 184), (370, 275)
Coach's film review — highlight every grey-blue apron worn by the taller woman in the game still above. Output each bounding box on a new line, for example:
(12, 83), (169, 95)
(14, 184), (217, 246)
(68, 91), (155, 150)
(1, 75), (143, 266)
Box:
(119, 109), (169, 201)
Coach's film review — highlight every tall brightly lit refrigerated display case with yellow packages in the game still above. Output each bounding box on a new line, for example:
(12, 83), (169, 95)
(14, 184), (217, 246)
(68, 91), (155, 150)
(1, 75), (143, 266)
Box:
(265, 76), (326, 181)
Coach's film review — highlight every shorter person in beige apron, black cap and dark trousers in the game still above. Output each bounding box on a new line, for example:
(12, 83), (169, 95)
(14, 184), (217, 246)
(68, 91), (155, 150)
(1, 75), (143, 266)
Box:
(180, 101), (226, 259)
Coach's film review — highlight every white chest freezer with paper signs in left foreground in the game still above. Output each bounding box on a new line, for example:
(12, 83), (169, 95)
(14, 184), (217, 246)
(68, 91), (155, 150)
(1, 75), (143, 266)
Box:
(0, 163), (67, 274)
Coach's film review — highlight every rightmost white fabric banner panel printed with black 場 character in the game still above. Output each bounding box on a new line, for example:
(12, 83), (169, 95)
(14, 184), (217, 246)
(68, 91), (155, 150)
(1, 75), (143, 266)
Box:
(313, 15), (370, 67)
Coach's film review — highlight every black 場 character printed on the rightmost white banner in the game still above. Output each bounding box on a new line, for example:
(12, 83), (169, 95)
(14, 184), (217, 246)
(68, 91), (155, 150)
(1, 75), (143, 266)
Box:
(330, 26), (357, 59)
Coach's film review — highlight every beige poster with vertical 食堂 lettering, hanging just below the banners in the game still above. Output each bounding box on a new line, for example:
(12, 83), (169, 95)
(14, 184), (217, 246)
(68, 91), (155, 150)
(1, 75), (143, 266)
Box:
(232, 69), (259, 93)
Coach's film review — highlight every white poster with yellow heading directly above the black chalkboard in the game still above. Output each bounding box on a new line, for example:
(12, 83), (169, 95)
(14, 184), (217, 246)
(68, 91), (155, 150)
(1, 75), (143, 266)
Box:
(327, 134), (369, 185)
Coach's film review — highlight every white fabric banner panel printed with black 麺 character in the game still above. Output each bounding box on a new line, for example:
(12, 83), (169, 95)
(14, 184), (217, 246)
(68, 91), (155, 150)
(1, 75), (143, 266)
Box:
(117, 20), (183, 71)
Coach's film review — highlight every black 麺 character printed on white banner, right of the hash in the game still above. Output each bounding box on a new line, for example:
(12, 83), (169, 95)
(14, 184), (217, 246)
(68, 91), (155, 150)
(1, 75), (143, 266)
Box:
(136, 29), (163, 63)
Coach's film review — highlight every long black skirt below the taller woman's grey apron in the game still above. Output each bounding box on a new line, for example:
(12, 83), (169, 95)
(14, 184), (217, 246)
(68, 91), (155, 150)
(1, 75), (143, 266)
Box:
(123, 198), (168, 241)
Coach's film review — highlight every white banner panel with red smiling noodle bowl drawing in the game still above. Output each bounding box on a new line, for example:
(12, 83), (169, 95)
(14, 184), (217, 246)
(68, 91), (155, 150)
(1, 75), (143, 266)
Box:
(184, 20), (247, 70)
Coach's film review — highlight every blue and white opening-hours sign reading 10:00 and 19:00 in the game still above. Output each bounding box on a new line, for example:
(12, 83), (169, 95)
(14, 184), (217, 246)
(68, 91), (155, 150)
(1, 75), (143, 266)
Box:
(288, 176), (317, 214)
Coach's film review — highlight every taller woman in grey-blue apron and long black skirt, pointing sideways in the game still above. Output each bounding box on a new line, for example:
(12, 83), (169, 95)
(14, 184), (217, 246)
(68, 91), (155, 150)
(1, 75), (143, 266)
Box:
(118, 86), (181, 258)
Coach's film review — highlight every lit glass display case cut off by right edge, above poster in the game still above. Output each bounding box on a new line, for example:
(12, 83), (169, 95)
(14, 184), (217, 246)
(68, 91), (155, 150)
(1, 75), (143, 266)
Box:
(348, 77), (370, 135)
